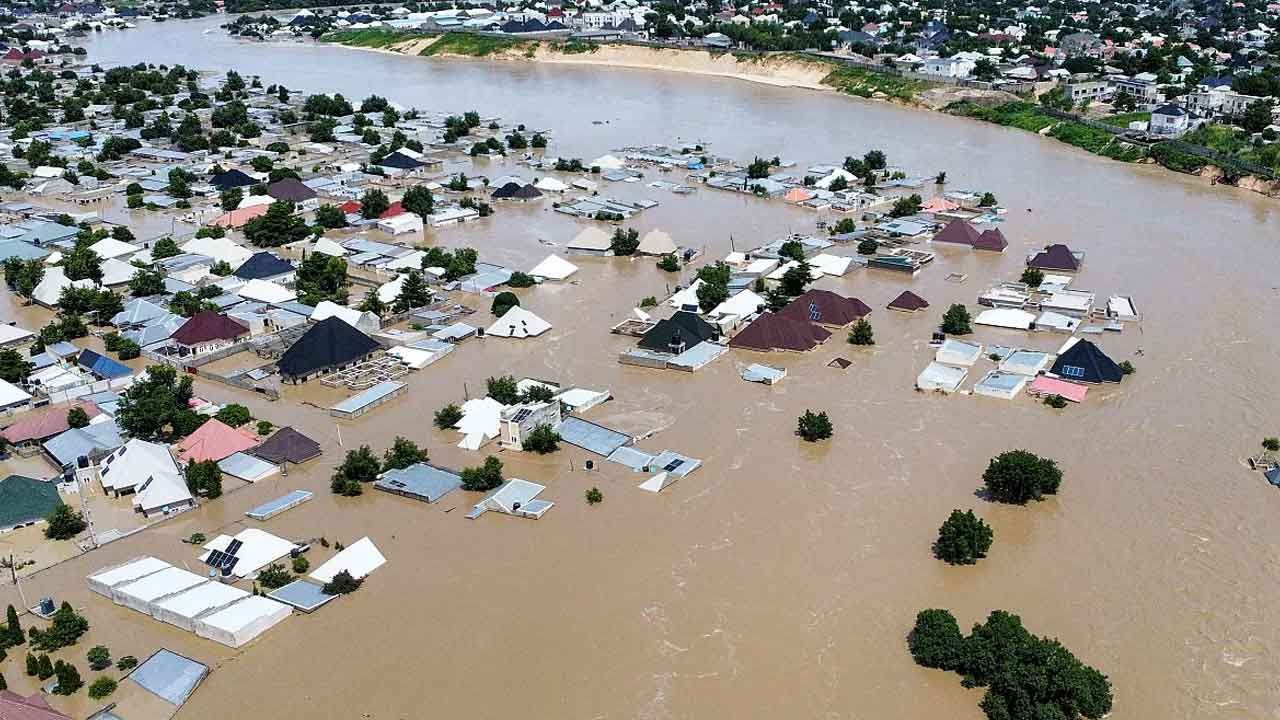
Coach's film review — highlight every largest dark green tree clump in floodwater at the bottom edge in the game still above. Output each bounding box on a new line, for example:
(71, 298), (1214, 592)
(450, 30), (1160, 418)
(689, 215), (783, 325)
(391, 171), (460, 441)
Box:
(908, 609), (1111, 720)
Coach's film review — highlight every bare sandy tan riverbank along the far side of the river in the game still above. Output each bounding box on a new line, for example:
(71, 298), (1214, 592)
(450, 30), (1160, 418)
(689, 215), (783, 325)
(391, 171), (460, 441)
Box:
(309, 35), (1280, 197)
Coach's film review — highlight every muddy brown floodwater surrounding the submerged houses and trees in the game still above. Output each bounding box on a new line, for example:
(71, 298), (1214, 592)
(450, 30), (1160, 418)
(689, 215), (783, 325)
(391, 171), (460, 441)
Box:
(0, 19), (1280, 720)
